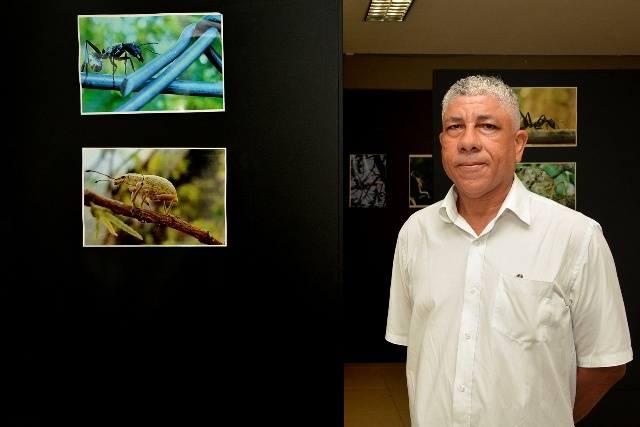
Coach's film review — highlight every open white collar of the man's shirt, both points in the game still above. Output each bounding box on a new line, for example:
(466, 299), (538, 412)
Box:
(438, 173), (531, 225)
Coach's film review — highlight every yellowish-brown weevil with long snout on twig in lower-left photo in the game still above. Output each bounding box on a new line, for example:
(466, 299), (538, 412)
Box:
(85, 169), (178, 215)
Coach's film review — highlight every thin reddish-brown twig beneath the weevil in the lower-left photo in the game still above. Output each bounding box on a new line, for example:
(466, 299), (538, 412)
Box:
(84, 190), (224, 245)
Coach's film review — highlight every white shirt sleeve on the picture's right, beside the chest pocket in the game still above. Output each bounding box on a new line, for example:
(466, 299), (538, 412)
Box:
(571, 223), (633, 368)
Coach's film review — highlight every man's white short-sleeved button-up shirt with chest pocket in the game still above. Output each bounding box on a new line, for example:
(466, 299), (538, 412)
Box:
(385, 175), (633, 427)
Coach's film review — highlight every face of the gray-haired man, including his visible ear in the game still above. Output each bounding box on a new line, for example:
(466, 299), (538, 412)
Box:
(440, 95), (528, 199)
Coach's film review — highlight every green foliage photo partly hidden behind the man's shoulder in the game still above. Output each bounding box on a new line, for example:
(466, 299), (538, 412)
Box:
(516, 162), (576, 210)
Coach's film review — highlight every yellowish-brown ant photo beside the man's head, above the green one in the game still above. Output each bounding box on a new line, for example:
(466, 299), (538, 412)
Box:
(512, 87), (578, 147)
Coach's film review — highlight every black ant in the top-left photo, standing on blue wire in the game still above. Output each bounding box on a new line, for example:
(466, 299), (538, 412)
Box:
(80, 40), (160, 89)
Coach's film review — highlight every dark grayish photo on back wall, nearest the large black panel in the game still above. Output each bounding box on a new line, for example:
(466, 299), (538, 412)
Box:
(349, 154), (387, 208)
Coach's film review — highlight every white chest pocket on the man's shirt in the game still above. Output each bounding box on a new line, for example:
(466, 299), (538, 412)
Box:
(491, 274), (554, 343)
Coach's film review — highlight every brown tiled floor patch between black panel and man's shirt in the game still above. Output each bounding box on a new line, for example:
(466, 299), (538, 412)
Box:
(344, 363), (411, 427)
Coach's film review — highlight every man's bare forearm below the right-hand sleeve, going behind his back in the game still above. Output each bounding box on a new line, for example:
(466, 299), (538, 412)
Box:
(573, 365), (627, 423)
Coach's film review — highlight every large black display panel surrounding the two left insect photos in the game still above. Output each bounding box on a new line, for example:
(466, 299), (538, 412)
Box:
(16, 0), (343, 425)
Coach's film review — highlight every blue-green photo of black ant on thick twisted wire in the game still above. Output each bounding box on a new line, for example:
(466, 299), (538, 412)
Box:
(78, 13), (224, 115)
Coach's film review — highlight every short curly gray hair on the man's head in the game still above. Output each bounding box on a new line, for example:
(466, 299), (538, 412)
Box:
(442, 75), (520, 130)
